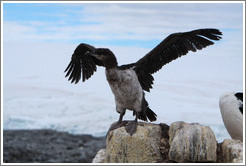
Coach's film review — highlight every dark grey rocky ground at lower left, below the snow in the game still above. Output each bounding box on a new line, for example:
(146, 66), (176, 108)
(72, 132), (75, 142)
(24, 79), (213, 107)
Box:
(3, 130), (106, 163)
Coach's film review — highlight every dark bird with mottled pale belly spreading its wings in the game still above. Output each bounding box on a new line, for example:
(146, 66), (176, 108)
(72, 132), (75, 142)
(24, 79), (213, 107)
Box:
(65, 29), (222, 135)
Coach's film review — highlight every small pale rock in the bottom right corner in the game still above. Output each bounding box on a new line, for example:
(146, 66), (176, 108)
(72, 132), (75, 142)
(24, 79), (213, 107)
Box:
(221, 139), (243, 163)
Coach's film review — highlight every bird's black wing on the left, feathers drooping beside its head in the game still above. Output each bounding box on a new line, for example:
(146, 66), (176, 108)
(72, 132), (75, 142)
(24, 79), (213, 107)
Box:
(64, 43), (103, 84)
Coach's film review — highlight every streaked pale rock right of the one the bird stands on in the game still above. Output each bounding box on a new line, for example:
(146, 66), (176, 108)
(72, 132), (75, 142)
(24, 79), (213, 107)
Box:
(169, 122), (217, 162)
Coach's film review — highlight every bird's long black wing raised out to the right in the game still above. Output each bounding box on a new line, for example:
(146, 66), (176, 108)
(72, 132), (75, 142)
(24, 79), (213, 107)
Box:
(131, 29), (222, 91)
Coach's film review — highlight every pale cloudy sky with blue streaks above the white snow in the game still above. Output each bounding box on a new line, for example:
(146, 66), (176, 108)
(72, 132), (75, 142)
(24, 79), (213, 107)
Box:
(3, 2), (243, 49)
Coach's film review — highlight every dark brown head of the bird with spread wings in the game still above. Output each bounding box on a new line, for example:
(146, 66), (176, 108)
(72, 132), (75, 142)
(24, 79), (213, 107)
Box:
(89, 48), (118, 68)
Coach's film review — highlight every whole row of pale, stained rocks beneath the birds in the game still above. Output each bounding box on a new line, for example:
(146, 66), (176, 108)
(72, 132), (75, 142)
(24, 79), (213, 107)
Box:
(93, 122), (243, 163)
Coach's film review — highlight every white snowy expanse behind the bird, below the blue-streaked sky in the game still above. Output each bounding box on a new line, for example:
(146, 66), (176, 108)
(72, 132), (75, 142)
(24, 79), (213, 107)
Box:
(3, 42), (243, 142)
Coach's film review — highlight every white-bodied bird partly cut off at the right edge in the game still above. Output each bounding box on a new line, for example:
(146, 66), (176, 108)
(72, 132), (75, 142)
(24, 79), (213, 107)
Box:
(219, 92), (243, 141)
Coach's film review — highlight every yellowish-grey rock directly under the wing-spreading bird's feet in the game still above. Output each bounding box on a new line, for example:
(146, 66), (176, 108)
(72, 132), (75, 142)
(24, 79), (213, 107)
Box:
(105, 122), (163, 163)
